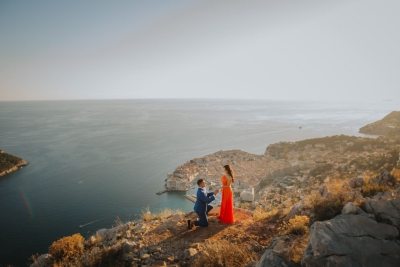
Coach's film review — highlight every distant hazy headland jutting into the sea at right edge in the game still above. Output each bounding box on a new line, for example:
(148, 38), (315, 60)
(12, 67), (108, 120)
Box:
(360, 111), (400, 135)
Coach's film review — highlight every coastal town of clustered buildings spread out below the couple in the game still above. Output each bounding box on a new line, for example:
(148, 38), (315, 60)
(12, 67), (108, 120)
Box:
(165, 138), (400, 208)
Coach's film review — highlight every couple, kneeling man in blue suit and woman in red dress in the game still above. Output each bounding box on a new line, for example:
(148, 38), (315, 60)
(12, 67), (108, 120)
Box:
(187, 165), (235, 229)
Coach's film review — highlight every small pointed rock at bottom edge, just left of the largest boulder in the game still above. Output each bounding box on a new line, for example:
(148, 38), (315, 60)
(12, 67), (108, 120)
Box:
(256, 236), (300, 267)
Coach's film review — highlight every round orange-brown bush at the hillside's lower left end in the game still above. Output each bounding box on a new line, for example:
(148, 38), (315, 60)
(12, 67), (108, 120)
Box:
(49, 234), (84, 261)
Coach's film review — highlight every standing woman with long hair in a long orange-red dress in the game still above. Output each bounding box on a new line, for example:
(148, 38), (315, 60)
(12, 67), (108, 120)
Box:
(218, 165), (235, 224)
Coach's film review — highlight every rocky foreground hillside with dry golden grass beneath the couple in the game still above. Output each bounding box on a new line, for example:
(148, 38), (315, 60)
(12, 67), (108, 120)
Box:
(31, 171), (400, 267)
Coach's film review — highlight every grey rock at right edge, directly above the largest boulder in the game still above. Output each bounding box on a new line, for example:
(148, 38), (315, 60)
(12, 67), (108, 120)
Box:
(365, 198), (400, 227)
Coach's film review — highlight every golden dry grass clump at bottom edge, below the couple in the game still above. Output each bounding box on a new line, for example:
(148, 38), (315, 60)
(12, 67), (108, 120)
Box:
(189, 240), (252, 267)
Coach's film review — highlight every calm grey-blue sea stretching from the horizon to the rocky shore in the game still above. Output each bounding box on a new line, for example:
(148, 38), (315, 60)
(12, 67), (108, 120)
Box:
(0, 100), (400, 266)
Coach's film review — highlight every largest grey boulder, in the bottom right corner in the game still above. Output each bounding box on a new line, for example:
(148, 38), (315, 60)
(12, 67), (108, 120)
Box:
(301, 214), (400, 267)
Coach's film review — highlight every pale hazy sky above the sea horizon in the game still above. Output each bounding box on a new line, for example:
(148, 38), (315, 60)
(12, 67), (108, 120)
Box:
(0, 0), (400, 101)
